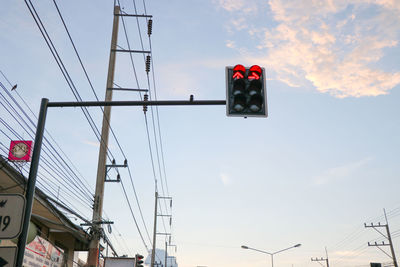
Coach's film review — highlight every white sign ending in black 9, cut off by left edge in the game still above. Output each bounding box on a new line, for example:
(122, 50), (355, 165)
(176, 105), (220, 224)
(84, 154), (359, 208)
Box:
(0, 194), (25, 239)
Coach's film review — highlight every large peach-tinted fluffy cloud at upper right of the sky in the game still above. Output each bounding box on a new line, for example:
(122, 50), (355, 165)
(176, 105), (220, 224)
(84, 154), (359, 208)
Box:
(219, 0), (400, 98)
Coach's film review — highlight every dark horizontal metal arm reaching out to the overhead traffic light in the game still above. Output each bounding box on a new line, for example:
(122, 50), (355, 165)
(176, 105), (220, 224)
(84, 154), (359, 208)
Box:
(47, 100), (226, 107)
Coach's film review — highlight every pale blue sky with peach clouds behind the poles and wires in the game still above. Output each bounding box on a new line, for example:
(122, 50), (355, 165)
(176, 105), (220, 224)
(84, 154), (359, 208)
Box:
(0, 0), (400, 267)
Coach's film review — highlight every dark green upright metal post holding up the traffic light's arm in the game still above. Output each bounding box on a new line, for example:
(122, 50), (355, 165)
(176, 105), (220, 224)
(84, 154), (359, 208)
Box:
(16, 98), (49, 267)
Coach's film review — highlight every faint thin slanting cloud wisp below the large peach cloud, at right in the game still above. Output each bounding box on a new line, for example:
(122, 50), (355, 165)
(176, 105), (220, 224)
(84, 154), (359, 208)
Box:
(314, 158), (372, 185)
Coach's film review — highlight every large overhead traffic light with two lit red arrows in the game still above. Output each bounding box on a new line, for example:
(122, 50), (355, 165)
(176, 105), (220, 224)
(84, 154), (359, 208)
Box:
(226, 65), (268, 117)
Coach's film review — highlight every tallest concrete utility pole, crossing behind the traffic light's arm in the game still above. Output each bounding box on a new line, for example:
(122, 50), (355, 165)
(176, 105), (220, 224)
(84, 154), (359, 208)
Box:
(87, 6), (120, 267)
